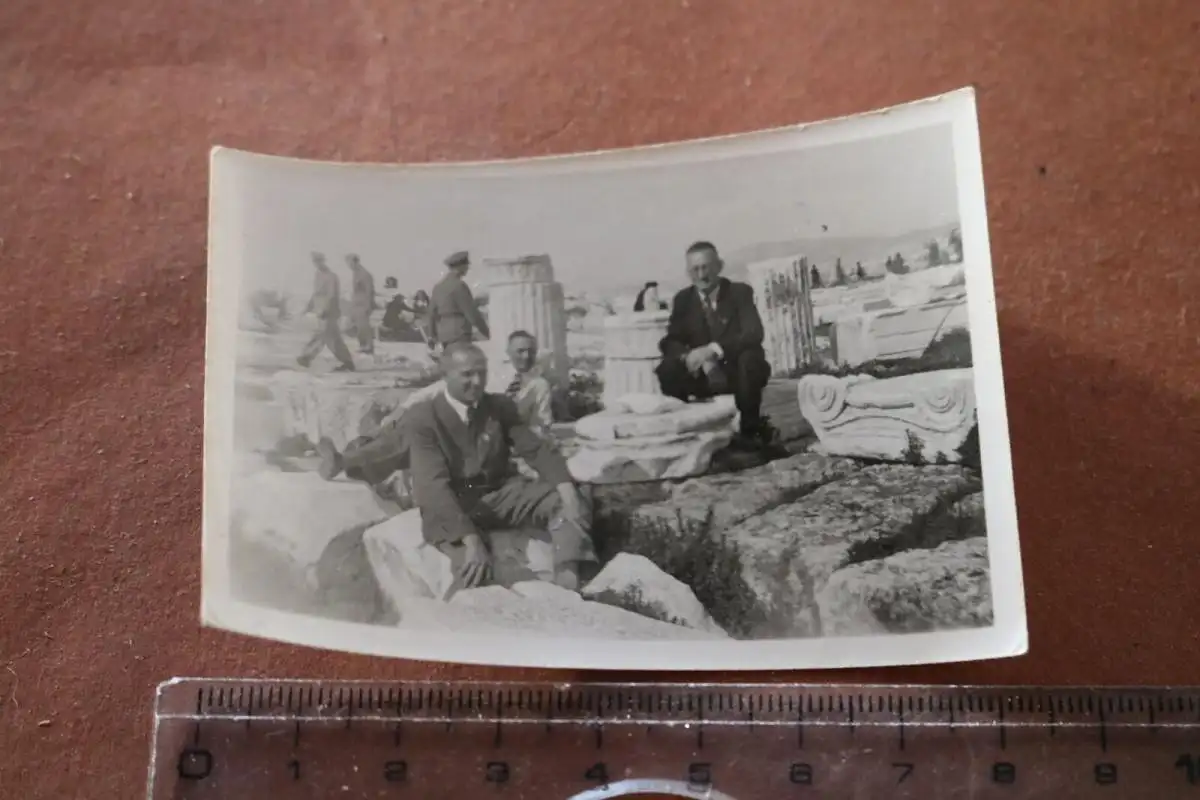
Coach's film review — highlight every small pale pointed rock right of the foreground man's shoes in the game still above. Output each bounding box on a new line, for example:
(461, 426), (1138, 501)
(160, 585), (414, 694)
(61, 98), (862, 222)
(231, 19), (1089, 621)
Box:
(582, 553), (725, 634)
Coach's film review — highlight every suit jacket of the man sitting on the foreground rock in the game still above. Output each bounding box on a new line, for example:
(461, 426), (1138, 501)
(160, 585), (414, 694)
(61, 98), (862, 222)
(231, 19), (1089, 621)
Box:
(403, 393), (572, 543)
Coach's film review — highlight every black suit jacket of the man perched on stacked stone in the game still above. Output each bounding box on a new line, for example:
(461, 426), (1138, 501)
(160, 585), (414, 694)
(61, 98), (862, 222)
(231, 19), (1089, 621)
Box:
(659, 278), (763, 360)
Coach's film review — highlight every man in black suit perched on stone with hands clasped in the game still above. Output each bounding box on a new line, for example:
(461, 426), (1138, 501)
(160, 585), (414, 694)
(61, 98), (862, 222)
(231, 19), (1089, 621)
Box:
(656, 241), (770, 446)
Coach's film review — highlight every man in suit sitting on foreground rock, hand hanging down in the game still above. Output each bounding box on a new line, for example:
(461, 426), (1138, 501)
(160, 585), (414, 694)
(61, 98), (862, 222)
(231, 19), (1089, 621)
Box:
(323, 342), (596, 589)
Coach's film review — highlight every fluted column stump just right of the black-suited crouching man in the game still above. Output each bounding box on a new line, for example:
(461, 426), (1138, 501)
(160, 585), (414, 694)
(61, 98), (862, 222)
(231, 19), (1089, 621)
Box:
(746, 258), (817, 377)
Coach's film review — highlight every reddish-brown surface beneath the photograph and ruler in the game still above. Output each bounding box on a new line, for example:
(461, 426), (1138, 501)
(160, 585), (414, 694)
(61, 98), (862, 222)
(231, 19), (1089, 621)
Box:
(0, 0), (1200, 798)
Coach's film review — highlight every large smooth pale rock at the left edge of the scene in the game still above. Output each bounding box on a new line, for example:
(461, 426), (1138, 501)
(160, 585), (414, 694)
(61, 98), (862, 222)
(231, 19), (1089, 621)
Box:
(230, 470), (389, 587)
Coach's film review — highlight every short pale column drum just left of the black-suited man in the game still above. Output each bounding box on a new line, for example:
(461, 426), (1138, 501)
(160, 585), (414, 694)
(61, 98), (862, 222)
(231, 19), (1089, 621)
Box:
(601, 311), (671, 405)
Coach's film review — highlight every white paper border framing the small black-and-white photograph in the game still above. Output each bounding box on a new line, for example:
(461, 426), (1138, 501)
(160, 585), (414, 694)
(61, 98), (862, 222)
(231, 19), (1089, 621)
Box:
(200, 88), (1028, 672)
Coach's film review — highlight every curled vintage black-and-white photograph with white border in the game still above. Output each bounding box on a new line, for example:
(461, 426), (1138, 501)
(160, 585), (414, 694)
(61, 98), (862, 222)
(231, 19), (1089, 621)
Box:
(203, 90), (1027, 670)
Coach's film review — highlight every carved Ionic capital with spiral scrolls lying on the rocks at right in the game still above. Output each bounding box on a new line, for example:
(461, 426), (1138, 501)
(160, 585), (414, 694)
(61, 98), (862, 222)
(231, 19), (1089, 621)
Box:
(797, 368), (976, 463)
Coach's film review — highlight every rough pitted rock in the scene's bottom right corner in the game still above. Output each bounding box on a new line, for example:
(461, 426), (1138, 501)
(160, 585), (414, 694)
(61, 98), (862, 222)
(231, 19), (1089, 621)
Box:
(816, 536), (992, 636)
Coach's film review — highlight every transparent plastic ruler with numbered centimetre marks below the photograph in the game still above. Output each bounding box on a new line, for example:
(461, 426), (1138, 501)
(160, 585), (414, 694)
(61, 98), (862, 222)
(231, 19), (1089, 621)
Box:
(149, 679), (1200, 800)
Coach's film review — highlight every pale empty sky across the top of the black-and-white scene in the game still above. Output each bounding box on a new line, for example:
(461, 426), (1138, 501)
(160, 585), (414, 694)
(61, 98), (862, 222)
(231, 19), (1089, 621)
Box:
(226, 125), (959, 295)
